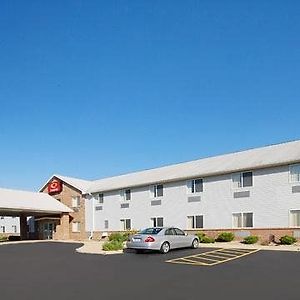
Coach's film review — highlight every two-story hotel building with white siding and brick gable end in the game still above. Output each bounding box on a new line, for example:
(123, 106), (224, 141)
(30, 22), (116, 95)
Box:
(37, 141), (300, 239)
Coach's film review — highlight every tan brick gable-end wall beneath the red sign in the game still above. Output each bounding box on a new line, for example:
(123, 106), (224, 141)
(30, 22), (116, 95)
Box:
(43, 182), (88, 240)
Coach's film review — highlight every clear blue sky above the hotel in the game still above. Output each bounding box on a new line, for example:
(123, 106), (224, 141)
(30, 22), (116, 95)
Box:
(0, 0), (300, 190)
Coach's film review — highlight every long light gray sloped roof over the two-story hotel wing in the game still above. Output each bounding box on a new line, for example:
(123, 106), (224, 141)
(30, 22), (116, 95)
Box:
(49, 140), (300, 193)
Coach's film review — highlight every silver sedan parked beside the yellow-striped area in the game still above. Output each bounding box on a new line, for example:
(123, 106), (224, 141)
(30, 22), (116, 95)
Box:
(126, 227), (199, 254)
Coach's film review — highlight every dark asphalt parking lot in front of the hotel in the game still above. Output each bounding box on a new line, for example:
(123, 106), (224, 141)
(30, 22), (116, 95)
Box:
(0, 242), (300, 300)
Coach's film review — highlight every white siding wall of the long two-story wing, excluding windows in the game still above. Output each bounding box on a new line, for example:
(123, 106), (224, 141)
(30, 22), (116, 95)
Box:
(85, 166), (300, 236)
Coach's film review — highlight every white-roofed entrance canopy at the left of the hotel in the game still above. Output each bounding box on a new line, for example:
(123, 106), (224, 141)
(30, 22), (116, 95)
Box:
(0, 188), (73, 216)
